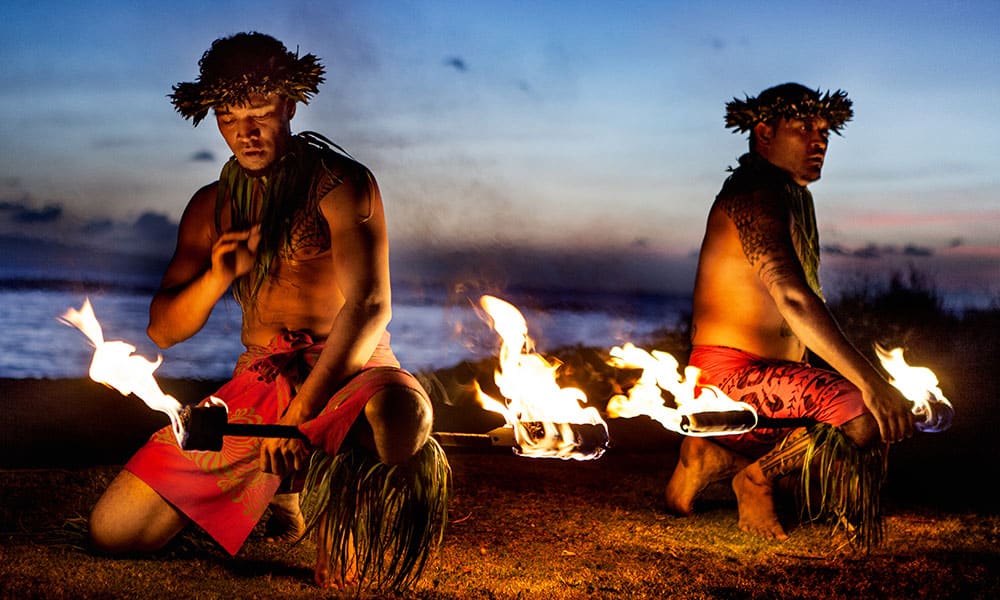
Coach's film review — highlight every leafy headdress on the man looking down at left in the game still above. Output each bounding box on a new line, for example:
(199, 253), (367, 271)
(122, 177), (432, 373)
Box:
(169, 32), (325, 125)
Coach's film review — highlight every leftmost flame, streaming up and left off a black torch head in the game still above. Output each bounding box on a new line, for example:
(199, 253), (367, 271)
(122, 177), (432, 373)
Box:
(59, 298), (184, 446)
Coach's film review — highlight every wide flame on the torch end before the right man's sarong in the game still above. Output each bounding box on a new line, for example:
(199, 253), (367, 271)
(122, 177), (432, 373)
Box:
(607, 343), (757, 436)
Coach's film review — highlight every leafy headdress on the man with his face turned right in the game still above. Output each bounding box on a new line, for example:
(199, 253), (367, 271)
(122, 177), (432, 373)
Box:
(726, 83), (854, 135)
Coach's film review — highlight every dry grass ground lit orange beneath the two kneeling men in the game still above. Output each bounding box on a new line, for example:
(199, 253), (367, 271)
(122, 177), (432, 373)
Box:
(0, 442), (1000, 598)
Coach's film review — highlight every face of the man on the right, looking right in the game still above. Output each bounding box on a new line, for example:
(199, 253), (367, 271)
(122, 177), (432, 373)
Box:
(754, 117), (830, 185)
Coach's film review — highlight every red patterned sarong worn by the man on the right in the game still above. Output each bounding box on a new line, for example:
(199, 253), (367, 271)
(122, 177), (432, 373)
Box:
(688, 346), (869, 457)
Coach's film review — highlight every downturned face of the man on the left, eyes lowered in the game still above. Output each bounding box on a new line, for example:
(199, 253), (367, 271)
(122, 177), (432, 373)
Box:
(215, 94), (295, 172)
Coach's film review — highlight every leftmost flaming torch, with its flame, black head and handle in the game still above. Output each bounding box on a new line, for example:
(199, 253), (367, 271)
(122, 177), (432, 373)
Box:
(59, 298), (305, 450)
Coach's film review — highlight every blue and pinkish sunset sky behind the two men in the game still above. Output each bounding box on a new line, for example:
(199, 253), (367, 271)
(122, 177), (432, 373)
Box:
(0, 0), (1000, 300)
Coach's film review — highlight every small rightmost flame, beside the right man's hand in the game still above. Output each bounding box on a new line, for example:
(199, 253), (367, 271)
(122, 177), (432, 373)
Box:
(875, 344), (955, 431)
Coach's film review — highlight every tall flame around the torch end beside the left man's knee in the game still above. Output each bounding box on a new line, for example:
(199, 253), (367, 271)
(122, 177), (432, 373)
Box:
(477, 295), (608, 460)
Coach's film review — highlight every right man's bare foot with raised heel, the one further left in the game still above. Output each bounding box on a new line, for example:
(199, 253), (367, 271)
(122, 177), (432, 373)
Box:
(666, 437), (750, 516)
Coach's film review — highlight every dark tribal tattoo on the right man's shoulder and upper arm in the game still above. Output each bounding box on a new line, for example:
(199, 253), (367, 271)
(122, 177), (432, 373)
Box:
(719, 194), (798, 285)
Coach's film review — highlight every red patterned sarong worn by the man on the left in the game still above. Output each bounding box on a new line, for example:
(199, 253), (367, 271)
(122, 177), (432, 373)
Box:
(125, 332), (426, 554)
